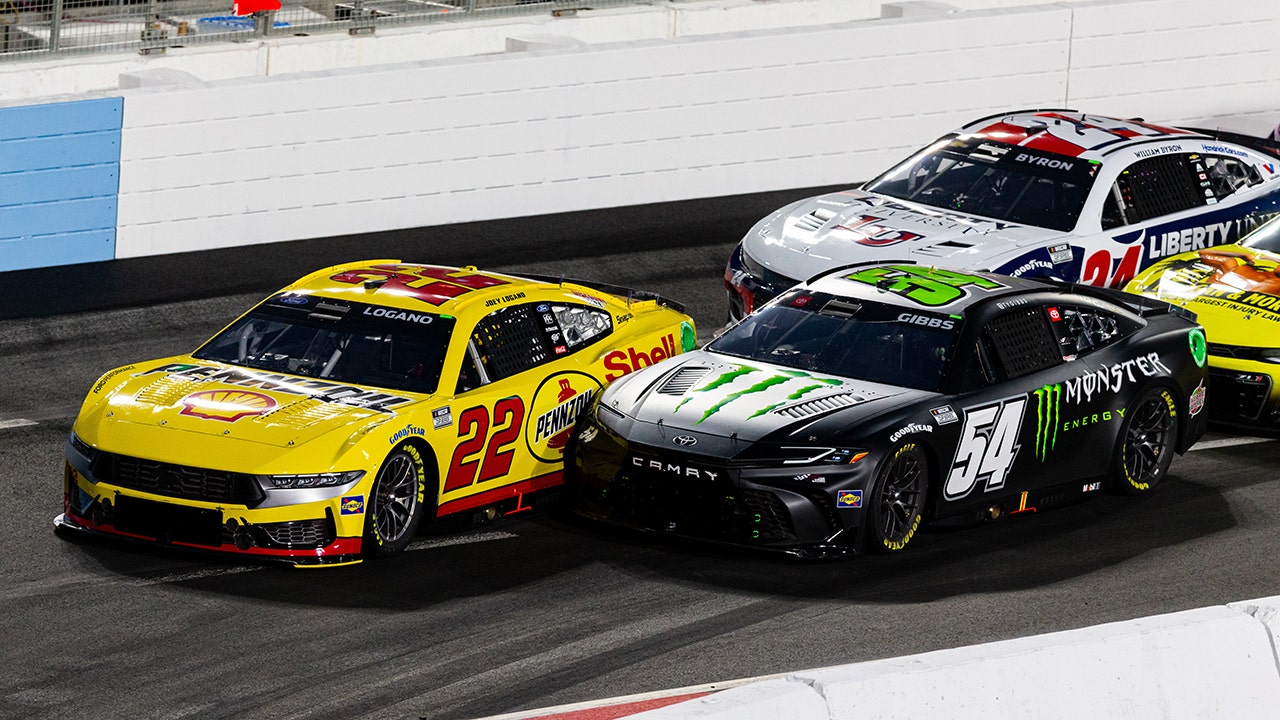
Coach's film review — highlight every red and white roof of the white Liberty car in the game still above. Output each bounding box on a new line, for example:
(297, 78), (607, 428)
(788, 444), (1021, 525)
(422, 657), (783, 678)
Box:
(956, 110), (1212, 160)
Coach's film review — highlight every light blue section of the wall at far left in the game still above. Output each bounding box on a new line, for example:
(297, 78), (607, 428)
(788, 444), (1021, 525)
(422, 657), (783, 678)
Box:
(0, 97), (124, 272)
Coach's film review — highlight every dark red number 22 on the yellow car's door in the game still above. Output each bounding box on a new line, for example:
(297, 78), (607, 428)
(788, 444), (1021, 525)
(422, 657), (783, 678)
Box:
(444, 397), (525, 492)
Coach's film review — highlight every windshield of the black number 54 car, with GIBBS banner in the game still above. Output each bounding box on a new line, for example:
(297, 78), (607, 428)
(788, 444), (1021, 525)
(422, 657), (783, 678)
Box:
(707, 290), (960, 391)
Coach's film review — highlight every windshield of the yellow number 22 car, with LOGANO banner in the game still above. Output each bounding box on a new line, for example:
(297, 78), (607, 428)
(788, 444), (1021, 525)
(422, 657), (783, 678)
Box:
(195, 295), (454, 393)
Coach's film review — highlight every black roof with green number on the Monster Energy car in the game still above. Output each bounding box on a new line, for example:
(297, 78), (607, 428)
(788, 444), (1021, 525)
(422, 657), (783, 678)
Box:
(805, 263), (1054, 314)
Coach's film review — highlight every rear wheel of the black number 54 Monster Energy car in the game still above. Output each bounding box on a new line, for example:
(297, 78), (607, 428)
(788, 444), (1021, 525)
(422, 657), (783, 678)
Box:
(1112, 387), (1178, 495)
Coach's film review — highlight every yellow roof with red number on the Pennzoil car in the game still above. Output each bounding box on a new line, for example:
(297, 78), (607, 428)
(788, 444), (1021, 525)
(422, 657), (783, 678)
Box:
(280, 260), (560, 315)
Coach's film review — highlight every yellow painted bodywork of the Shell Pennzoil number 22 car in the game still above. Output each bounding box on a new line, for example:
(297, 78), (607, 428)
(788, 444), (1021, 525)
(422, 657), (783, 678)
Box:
(67, 260), (694, 559)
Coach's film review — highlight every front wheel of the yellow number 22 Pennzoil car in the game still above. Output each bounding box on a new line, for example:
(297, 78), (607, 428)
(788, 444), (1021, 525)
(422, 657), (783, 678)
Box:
(364, 445), (428, 557)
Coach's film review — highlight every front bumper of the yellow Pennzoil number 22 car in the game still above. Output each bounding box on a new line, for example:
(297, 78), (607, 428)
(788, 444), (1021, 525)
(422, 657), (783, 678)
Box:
(63, 453), (365, 566)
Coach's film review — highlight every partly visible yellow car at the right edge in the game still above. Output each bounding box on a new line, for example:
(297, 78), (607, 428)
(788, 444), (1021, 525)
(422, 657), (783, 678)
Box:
(1125, 245), (1280, 417)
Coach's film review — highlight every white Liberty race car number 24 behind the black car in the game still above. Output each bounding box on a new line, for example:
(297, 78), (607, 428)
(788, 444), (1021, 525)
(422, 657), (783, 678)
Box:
(724, 110), (1280, 319)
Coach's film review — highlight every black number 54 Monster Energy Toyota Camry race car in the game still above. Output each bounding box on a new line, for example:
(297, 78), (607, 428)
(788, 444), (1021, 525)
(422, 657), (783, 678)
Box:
(570, 264), (1206, 556)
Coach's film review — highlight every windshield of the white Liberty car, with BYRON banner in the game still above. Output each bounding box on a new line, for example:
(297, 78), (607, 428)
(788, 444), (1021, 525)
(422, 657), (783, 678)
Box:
(865, 137), (1101, 231)
